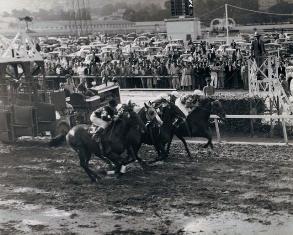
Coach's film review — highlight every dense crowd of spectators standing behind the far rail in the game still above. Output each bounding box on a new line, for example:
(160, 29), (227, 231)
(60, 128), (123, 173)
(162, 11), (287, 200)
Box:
(42, 35), (284, 93)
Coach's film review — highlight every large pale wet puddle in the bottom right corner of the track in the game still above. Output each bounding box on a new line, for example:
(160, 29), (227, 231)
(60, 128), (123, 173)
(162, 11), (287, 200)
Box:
(183, 212), (293, 235)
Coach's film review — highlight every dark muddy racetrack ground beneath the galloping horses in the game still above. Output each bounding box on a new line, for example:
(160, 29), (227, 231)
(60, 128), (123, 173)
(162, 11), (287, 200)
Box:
(0, 140), (293, 235)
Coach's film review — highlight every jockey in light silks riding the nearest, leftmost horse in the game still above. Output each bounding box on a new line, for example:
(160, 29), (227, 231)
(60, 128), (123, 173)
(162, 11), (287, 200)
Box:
(90, 99), (118, 142)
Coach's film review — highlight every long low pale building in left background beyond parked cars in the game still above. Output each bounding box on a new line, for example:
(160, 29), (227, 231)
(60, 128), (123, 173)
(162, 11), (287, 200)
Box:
(0, 19), (167, 37)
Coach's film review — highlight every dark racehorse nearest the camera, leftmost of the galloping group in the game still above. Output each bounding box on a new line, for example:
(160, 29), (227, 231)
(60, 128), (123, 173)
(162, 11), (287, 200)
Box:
(66, 103), (144, 182)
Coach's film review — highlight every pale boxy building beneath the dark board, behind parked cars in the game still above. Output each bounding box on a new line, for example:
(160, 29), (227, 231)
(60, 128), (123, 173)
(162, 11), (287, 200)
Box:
(165, 17), (202, 41)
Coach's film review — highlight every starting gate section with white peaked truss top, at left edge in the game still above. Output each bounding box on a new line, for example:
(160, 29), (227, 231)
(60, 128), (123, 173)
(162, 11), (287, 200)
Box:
(0, 33), (56, 142)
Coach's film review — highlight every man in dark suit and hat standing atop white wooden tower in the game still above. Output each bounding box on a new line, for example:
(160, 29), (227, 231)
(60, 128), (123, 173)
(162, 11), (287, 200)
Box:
(251, 32), (266, 67)
